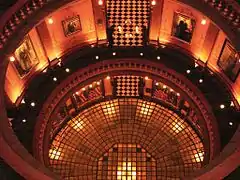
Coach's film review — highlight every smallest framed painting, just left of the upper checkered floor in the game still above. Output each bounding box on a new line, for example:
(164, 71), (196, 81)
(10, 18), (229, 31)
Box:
(62, 15), (82, 36)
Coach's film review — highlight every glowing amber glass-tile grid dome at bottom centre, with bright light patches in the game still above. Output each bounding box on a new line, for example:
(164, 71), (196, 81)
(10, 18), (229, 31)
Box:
(49, 98), (205, 179)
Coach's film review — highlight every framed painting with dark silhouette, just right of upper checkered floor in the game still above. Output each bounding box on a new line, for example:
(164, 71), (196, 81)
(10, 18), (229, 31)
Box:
(172, 12), (196, 43)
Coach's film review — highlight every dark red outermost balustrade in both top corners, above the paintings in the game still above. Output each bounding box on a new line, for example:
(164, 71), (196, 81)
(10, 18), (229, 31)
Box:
(0, 0), (240, 49)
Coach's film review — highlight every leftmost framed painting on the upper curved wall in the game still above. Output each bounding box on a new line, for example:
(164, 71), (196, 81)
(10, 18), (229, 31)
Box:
(14, 35), (39, 77)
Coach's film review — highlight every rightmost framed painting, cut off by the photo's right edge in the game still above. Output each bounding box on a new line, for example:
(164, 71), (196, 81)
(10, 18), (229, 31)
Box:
(217, 40), (240, 82)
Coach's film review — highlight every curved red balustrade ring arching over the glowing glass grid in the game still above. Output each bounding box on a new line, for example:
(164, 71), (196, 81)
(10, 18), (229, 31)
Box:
(34, 59), (219, 165)
